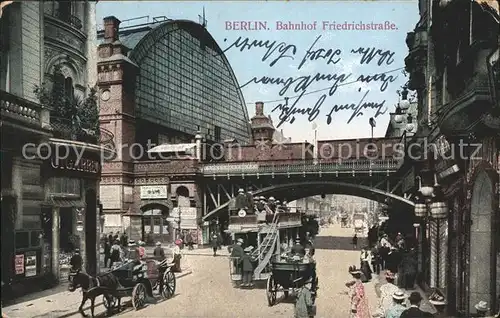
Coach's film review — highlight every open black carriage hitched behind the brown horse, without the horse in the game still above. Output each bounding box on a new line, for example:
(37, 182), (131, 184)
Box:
(103, 259), (176, 310)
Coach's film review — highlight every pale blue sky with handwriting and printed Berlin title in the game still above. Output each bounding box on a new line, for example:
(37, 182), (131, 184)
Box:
(97, 0), (419, 142)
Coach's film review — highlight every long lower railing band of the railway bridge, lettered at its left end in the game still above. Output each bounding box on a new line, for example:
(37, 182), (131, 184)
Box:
(202, 159), (402, 176)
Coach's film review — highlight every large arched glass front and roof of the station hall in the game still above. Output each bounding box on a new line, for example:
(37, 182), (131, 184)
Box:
(99, 20), (251, 142)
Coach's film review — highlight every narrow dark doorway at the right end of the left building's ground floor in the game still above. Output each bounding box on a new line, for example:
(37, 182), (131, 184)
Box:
(85, 189), (100, 275)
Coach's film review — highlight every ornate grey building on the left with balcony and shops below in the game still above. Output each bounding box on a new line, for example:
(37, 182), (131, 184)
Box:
(0, 1), (108, 296)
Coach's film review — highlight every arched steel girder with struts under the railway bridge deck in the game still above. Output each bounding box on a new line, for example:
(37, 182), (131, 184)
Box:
(203, 179), (415, 220)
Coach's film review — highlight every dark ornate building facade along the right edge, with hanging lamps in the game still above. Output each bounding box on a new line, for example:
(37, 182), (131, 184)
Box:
(405, 0), (500, 317)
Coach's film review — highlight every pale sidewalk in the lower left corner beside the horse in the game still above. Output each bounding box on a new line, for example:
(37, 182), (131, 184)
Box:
(2, 261), (193, 318)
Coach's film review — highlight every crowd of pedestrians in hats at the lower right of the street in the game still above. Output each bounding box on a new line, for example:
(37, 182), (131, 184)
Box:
(346, 232), (500, 318)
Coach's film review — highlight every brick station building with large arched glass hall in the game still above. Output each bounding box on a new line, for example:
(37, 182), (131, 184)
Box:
(98, 17), (250, 244)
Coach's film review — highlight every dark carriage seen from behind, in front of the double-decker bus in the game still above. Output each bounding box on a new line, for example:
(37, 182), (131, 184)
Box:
(266, 260), (318, 306)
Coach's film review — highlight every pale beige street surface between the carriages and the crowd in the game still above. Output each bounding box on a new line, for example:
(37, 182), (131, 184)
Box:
(76, 226), (377, 318)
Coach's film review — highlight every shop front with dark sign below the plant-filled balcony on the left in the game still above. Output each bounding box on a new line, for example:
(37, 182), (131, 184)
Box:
(42, 144), (101, 281)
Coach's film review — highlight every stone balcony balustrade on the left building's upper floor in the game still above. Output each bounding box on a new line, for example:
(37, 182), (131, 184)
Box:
(0, 90), (50, 126)
